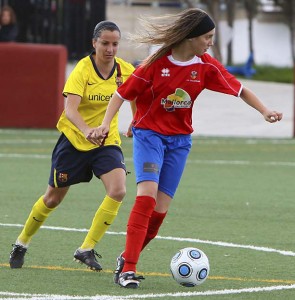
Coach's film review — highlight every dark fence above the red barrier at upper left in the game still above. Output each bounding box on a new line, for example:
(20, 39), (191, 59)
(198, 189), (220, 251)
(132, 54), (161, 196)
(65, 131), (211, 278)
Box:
(0, 0), (106, 59)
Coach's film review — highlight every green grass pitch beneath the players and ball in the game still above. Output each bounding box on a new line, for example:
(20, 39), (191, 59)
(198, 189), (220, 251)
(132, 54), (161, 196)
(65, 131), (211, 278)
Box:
(0, 130), (295, 300)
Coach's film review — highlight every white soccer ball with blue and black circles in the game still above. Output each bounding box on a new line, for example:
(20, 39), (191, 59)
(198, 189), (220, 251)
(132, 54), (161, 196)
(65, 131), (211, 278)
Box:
(170, 247), (210, 287)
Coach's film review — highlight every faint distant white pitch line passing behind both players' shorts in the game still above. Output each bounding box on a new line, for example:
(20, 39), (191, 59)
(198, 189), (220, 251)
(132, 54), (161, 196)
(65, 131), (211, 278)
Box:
(0, 153), (295, 167)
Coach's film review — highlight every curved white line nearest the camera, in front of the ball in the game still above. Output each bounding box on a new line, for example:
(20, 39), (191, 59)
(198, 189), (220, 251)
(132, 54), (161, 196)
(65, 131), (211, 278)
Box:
(0, 284), (295, 300)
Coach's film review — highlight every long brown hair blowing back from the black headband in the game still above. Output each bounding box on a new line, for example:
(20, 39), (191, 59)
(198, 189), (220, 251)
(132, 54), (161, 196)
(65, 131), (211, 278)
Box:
(129, 8), (207, 67)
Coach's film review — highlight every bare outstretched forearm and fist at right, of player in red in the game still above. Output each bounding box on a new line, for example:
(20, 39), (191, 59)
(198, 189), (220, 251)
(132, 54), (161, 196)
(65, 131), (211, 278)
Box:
(240, 87), (283, 123)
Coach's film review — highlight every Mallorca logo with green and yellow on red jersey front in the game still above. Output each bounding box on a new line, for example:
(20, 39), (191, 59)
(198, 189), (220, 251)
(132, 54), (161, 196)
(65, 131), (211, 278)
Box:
(161, 88), (192, 112)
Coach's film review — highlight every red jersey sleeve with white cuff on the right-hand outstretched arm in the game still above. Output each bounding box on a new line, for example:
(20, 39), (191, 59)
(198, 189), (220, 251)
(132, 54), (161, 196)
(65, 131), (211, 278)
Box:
(202, 55), (242, 97)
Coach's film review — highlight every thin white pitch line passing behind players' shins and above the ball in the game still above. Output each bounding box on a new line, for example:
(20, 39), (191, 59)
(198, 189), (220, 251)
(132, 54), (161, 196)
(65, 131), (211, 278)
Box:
(0, 223), (295, 256)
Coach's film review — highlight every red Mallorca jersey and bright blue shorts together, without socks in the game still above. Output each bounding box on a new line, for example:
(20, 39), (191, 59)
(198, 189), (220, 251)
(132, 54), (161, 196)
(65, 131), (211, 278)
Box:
(116, 53), (242, 198)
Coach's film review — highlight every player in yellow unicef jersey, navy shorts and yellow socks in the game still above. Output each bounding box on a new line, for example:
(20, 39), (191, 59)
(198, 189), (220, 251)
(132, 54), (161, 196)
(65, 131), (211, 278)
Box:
(9, 21), (134, 271)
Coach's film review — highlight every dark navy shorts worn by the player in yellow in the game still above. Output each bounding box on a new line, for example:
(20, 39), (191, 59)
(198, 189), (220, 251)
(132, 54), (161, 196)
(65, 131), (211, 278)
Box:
(48, 134), (126, 187)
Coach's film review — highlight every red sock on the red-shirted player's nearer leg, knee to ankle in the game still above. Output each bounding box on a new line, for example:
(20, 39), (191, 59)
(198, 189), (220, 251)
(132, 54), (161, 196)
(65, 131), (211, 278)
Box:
(122, 196), (156, 272)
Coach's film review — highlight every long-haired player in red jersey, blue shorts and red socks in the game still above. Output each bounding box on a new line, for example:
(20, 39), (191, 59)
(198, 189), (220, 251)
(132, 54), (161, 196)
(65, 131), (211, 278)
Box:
(92, 8), (282, 288)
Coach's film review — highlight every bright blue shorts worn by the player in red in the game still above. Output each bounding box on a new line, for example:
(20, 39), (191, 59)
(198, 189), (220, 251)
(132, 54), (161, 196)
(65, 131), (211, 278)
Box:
(132, 128), (192, 198)
